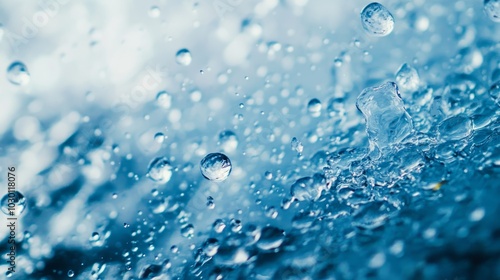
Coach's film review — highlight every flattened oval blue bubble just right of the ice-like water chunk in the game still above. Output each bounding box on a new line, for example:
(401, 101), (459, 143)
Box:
(438, 114), (472, 141)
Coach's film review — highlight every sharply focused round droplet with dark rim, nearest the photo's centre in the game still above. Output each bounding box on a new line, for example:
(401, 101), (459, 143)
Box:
(200, 153), (232, 182)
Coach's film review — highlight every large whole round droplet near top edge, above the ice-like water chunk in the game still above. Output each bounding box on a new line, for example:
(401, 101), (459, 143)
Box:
(361, 2), (394, 37)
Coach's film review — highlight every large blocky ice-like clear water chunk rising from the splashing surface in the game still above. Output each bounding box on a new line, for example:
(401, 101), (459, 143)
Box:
(356, 82), (413, 148)
